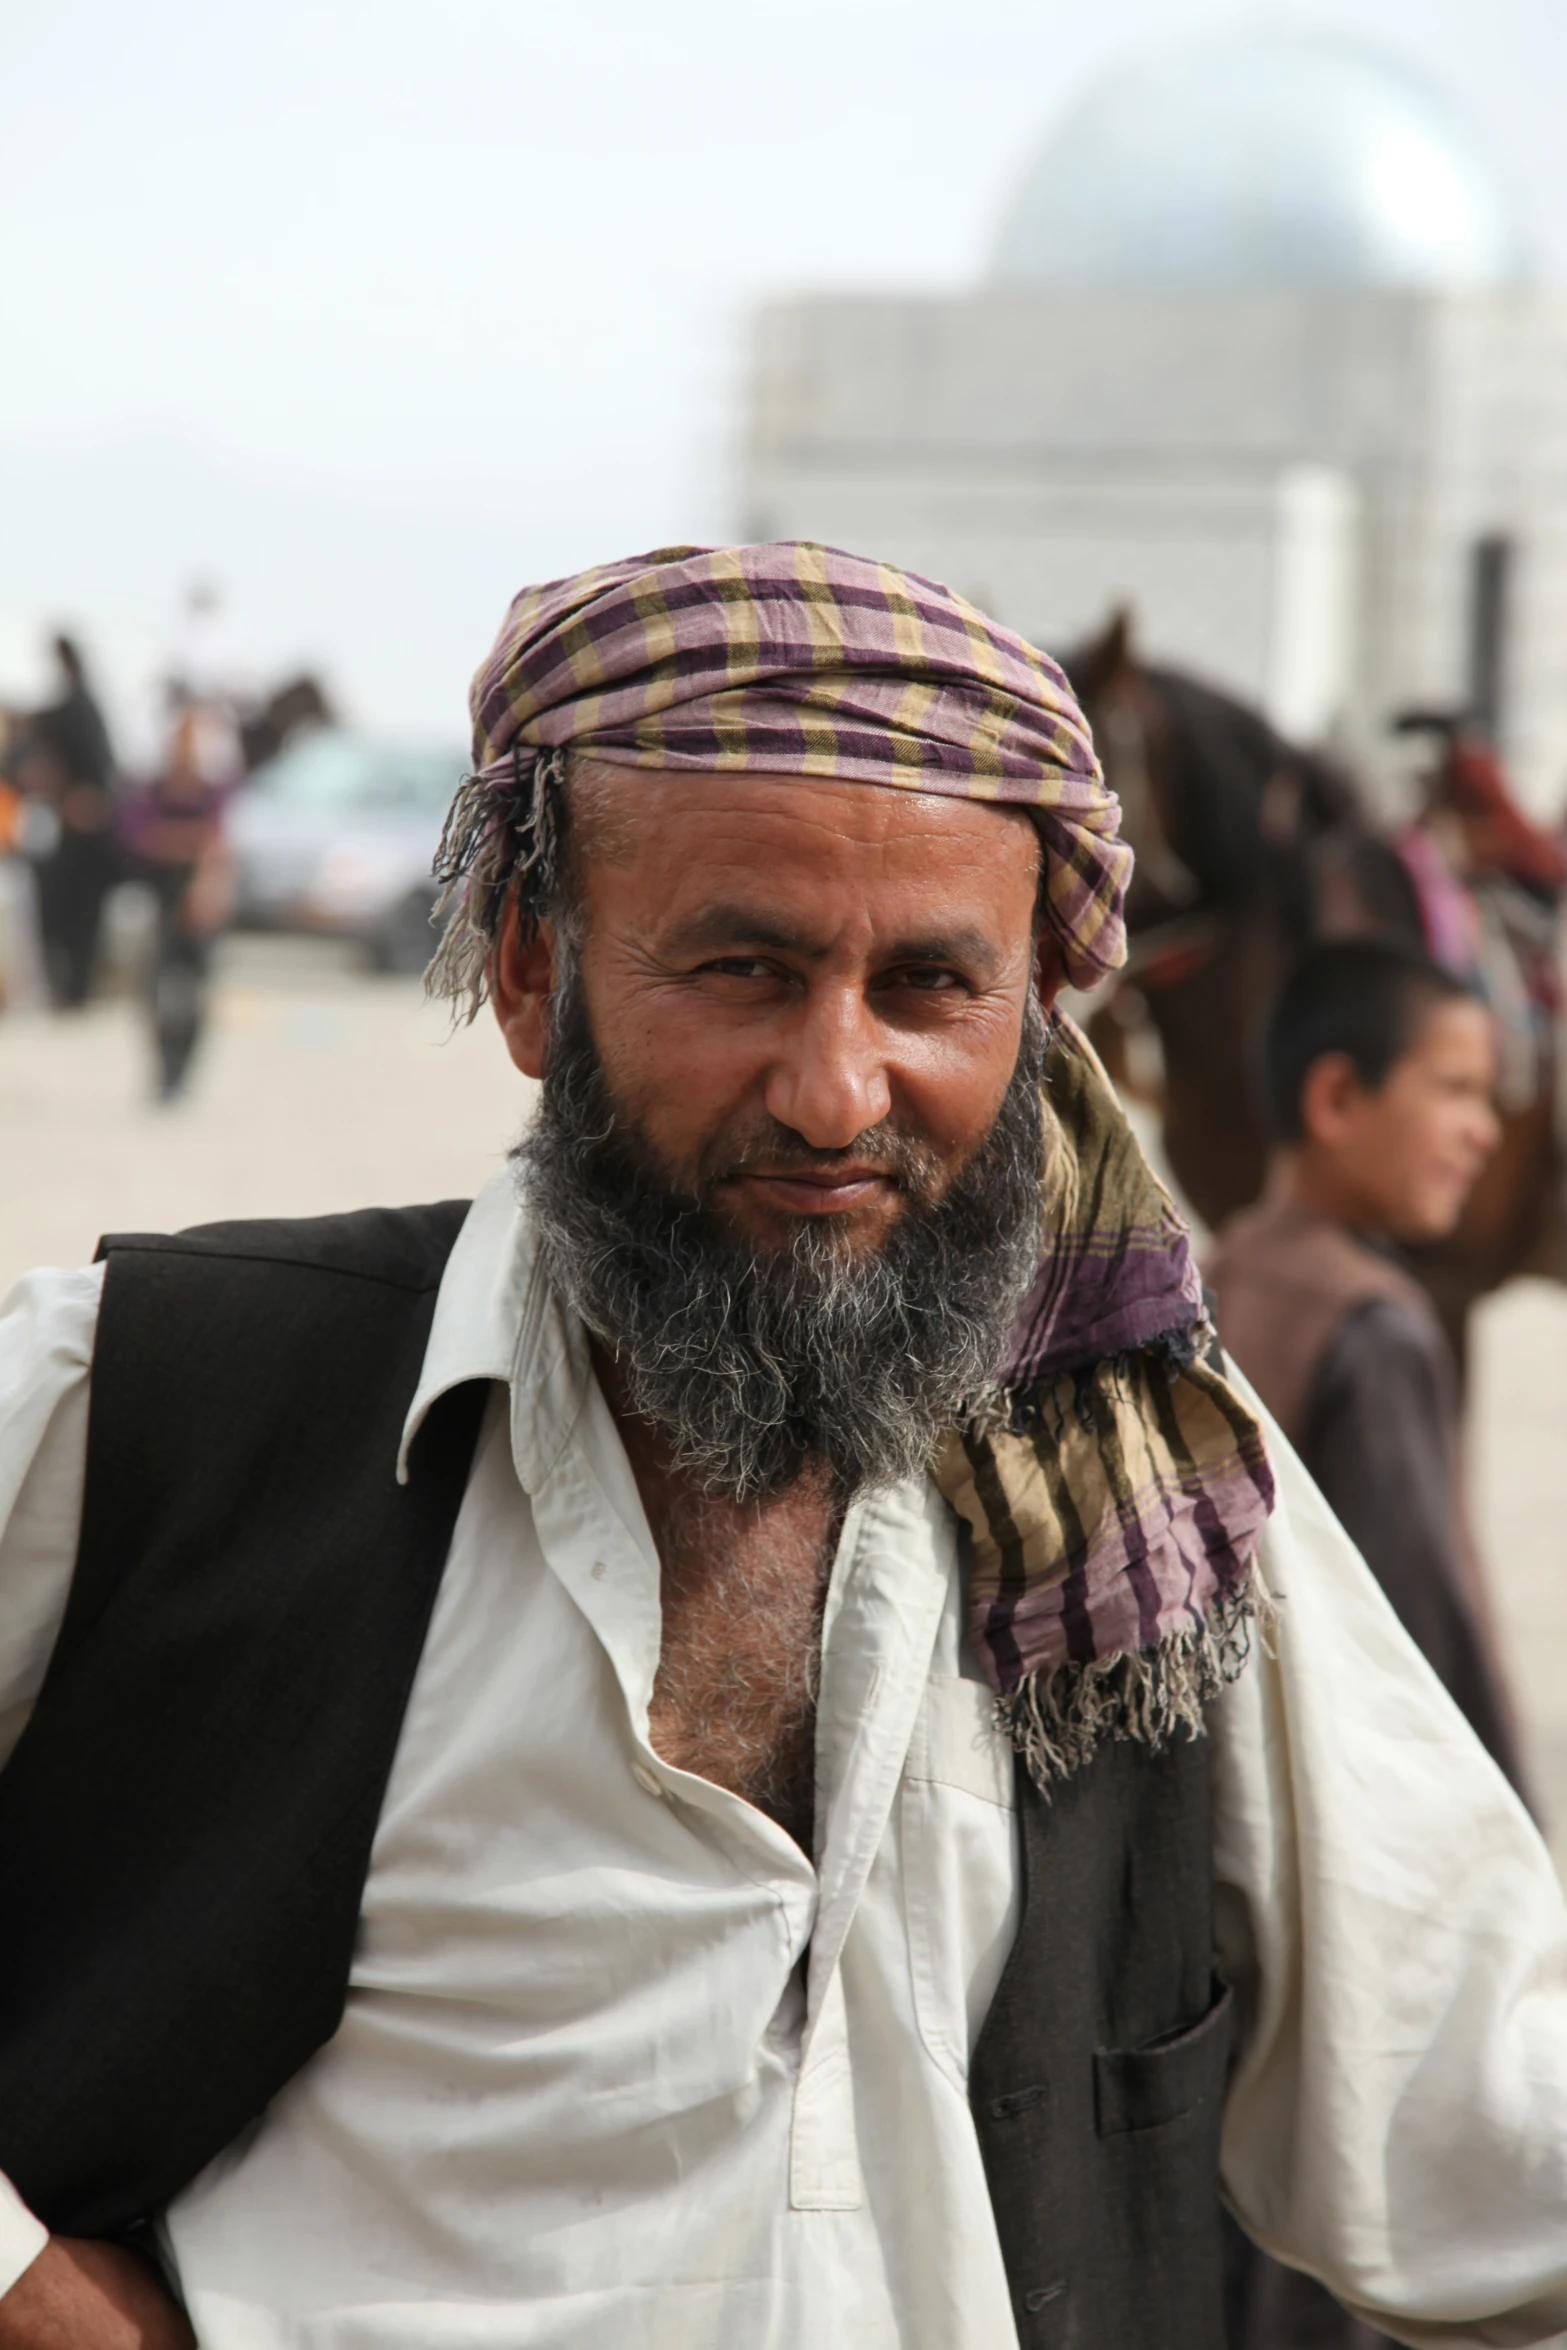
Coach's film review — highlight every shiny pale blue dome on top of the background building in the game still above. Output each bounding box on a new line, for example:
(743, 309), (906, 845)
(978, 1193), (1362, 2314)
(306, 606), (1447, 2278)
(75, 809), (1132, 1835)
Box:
(991, 31), (1525, 291)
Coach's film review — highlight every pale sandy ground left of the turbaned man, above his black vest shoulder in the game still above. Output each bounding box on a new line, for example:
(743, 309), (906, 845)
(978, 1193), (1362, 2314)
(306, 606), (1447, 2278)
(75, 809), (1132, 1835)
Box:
(0, 940), (531, 1278)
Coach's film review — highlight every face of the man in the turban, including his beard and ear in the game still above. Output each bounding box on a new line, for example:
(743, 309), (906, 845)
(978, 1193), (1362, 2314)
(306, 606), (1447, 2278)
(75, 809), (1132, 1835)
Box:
(491, 771), (1045, 1499)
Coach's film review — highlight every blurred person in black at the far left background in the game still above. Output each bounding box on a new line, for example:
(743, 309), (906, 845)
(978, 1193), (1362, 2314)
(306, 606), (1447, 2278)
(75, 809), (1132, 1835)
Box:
(12, 637), (120, 1011)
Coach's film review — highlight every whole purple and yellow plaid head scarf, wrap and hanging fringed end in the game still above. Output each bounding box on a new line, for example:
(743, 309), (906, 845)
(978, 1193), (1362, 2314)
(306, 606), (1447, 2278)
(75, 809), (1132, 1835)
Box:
(430, 543), (1273, 1786)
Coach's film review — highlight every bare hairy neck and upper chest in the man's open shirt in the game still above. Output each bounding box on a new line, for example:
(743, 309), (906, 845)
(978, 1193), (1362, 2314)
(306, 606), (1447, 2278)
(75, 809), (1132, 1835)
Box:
(594, 1342), (843, 1852)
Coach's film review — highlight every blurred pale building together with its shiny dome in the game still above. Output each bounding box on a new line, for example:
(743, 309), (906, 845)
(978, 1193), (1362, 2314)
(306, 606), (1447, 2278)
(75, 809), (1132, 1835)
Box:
(745, 31), (1567, 808)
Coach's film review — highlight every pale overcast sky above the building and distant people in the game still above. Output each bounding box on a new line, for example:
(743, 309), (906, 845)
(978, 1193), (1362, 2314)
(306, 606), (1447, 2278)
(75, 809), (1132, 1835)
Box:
(0, 0), (1567, 738)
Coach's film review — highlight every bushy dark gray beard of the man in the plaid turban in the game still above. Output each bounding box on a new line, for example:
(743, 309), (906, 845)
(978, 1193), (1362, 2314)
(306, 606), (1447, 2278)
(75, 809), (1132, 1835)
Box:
(512, 973), (1048, 1502)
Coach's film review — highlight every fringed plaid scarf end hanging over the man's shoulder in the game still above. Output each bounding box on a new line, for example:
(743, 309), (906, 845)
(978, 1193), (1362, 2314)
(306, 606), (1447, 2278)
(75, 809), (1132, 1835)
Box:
(935, 1015), (1273, 1786)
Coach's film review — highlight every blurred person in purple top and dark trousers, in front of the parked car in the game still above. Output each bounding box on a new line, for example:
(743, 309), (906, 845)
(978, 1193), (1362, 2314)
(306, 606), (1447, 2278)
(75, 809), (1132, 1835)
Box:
(125, 691), (237, 1102)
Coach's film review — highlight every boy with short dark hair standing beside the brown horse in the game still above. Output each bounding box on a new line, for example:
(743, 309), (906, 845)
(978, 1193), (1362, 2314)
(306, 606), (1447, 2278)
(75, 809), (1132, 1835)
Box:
(1208, 940), (1525, 2350)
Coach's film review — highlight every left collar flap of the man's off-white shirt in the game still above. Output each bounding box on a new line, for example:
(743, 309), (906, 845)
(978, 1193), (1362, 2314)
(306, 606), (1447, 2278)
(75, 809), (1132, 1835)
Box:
(397, 1168), (590, 1492)
